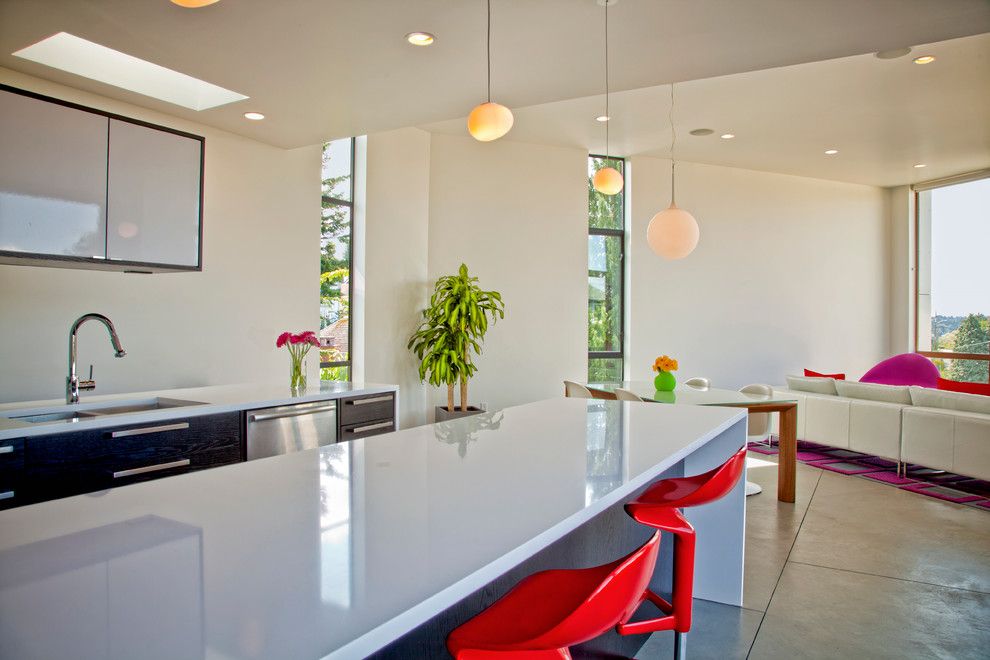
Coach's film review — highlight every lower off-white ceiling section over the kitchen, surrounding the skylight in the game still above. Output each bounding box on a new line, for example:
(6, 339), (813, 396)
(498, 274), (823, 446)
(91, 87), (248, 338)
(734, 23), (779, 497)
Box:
(0, 0), (990, 147)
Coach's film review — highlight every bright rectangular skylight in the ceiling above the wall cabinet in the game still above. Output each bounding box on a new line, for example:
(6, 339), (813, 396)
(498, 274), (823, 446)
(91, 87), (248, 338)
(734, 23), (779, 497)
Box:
(14, 32), (248, 110)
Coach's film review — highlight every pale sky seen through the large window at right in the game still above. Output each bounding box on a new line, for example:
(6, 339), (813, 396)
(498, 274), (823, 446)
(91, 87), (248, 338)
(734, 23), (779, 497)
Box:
(932, 179), (990, 316)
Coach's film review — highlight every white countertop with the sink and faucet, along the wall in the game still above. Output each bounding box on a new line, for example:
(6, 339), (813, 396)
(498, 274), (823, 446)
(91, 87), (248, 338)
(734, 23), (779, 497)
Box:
(0, 381), (398, 440)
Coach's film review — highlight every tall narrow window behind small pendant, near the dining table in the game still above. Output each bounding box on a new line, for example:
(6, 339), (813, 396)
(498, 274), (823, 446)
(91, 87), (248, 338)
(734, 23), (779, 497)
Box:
(588, 155), (625, 383)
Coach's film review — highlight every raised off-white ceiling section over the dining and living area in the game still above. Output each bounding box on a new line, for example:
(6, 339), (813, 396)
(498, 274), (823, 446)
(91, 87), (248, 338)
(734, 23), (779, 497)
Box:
(424, 34), (990, 186)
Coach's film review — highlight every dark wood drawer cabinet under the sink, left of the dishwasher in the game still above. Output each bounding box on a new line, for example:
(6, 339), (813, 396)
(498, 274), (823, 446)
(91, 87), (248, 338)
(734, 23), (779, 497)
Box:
(15, 412), (242, 506)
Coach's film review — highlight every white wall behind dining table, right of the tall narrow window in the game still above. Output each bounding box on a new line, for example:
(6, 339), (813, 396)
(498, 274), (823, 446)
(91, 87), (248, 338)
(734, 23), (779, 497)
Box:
(627, 157), (892, 388)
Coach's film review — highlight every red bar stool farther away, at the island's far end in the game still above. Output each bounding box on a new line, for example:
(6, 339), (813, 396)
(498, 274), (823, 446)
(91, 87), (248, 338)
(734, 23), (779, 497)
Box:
(617, 447), (746, 660)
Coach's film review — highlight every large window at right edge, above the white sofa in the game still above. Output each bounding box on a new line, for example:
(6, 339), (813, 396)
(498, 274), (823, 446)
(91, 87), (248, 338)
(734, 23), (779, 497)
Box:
(915, 178), (990, 383)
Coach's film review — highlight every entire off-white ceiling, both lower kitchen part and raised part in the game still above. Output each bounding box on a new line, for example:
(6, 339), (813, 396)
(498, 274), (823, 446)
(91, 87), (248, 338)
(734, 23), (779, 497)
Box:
(0, 0), (990, 185)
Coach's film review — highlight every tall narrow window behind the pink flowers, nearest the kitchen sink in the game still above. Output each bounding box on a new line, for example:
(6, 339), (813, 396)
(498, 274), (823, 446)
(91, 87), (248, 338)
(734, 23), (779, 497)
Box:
(320, 138), (354, 380)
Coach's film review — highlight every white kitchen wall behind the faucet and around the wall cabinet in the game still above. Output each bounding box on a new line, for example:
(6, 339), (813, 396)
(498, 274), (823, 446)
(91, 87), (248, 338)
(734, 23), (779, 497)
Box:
(0, 69), (320, 401)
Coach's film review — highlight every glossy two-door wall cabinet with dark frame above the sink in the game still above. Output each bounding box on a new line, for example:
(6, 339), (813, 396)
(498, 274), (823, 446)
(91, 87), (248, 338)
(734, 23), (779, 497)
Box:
(0, 85), (205, 272)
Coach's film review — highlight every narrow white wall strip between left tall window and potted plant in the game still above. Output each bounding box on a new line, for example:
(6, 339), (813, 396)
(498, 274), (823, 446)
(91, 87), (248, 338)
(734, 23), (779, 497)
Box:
(356, 128), (430, 428)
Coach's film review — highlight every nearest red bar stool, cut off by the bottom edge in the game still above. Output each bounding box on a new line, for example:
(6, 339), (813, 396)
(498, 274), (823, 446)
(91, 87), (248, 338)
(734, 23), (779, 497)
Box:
(447, 532), (660, 660)
